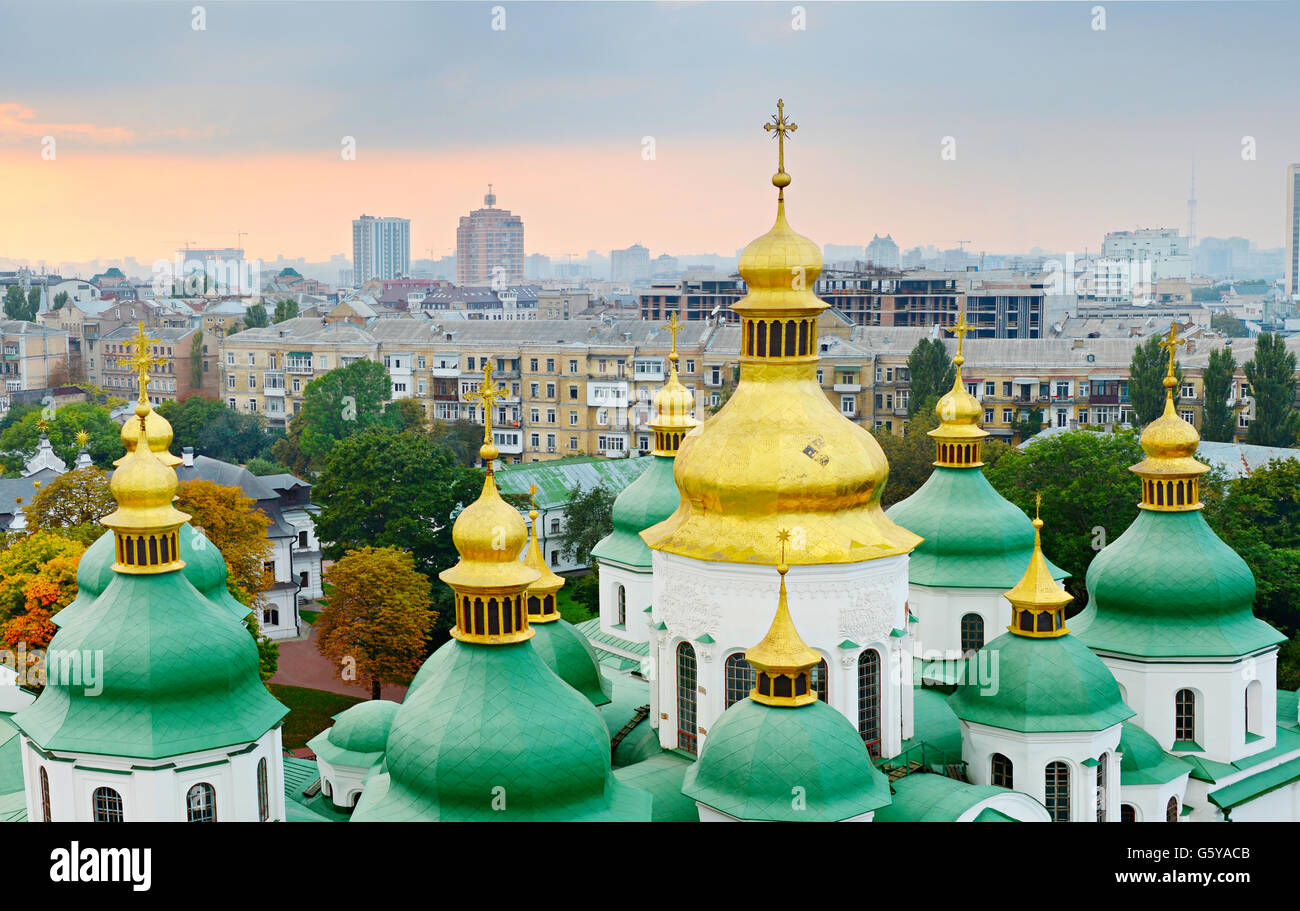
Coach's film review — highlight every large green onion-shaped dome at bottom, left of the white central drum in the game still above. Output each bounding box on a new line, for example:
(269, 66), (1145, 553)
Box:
(352, 639), (651, 821)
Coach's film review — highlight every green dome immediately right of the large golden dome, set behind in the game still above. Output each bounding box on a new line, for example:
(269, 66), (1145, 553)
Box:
(885, 467), (1069, 589)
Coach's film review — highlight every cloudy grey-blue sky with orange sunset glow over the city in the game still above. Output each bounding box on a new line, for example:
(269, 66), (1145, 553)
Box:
(0, 0), (1300, 269)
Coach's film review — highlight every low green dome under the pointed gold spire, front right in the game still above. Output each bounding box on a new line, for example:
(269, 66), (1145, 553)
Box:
(949, 633), (1134, 733)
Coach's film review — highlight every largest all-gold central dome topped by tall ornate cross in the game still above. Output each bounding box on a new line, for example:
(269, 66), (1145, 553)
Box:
(641, 101), (920, 565)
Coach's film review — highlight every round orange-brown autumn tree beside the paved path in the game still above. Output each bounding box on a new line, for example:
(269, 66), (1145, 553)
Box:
(315, 547), (436, 699)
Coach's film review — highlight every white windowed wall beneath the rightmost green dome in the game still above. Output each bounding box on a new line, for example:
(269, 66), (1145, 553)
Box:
(1099, 648), (1278, 763)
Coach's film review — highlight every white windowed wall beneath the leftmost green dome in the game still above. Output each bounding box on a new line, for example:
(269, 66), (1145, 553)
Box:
(22, 726), (285, 823)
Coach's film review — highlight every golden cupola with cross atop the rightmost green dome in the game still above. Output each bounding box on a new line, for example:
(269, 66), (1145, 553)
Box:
(1128, 322), (1210, 512)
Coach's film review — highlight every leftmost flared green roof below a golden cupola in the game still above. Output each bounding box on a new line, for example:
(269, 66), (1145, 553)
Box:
(13, 572), (289, 759)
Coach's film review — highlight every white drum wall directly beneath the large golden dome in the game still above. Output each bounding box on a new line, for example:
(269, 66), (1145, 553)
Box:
(651, 552), (911, 756)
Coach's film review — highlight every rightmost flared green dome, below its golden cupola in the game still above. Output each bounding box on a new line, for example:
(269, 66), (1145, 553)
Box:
(1070, 509), (1286, 658)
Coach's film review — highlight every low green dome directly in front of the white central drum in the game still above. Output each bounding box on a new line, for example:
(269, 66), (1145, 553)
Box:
(681, 699), (889, 823)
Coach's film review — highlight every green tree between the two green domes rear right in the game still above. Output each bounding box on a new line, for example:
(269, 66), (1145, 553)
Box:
(984, 430), (1145, 609)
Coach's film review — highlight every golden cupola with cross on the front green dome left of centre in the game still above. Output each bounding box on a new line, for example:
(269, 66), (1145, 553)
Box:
(438, 360), (538, 645)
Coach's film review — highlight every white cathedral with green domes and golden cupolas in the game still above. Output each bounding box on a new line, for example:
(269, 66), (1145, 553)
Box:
(0, 105), (1300, 823)
